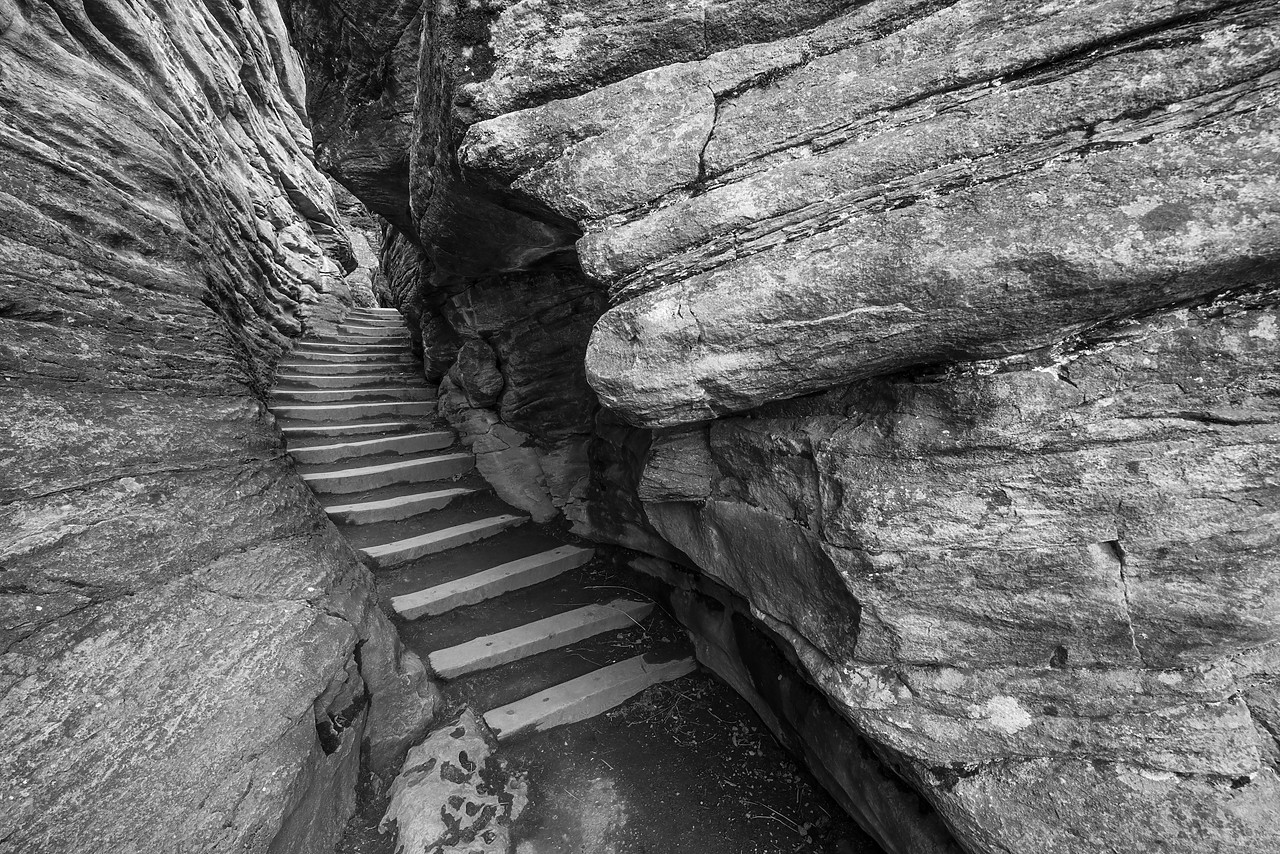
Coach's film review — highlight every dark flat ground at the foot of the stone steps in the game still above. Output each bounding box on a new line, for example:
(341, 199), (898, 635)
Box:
(339, 672), (881, 854)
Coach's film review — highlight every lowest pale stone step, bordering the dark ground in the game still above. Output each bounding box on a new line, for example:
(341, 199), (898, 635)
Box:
(484, 656), (698, 741)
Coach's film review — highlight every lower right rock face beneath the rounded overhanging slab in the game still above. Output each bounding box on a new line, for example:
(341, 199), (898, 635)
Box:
(641, 297), (1280, 851)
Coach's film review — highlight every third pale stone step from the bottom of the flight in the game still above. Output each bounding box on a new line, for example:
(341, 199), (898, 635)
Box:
(392, 545), (595, 620)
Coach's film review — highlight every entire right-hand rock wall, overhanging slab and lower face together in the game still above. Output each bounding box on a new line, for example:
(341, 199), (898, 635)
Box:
(285, 0), (1280, 854)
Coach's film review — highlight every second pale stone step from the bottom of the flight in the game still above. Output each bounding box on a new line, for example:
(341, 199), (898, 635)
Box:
(428, 599), (653, 679)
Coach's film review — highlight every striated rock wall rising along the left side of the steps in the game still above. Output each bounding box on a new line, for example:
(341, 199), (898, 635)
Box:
(0, 0), (434, 854)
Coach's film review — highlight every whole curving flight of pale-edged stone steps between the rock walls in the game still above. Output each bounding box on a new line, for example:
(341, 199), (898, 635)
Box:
(270, 309), (695, 740)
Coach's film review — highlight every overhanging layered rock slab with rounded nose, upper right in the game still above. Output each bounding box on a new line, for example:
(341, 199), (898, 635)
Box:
(460, 0), (1280, 425)
